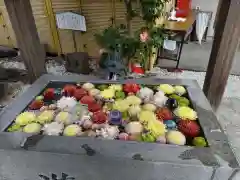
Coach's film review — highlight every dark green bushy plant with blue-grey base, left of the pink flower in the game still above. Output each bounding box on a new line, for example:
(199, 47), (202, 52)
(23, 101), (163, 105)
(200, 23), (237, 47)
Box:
(95, 26), (138, 75)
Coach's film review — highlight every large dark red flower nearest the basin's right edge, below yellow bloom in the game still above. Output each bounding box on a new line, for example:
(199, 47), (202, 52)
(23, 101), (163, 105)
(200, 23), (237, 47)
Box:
(178, 120), (200, 137)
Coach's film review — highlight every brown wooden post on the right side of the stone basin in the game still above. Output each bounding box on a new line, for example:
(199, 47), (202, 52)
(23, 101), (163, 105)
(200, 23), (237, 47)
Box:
(203, 0), (240, 110)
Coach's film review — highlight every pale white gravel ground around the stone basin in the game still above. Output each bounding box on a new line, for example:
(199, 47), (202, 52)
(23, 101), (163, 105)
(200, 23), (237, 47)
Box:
(0, 60), (240, 176)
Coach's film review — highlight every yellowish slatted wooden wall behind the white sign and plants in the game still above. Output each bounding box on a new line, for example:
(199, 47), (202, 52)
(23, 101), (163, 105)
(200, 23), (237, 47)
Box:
(0, 0), (172, 56)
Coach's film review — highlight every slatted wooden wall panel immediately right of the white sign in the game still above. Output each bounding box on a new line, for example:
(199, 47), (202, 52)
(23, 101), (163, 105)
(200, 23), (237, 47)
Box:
(81, 0), (112, 56)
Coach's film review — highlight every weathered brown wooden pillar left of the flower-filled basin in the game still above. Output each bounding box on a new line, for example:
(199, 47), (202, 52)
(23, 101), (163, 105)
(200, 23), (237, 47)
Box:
(4, 0), (46, 82)
